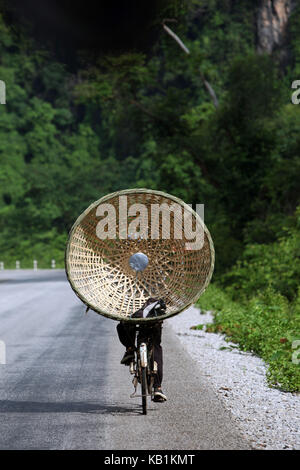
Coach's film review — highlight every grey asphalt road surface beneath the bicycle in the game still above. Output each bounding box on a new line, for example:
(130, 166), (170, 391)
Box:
(0, 270), (250, 450)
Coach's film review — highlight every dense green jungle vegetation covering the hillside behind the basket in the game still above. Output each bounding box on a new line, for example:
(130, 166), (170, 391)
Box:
(0, 0), (300, 391)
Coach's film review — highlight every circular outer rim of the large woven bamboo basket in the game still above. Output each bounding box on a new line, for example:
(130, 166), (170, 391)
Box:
(65, 188), (215, 323)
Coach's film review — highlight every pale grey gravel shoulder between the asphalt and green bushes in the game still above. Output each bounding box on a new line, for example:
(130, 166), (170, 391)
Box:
(167, 307), (300, 450)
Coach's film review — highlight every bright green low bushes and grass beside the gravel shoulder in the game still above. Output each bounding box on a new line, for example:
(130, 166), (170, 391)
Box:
(196, 284), (300, 392)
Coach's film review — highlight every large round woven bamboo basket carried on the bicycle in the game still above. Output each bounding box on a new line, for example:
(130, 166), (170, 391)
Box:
(65, 189), (214, 323)
